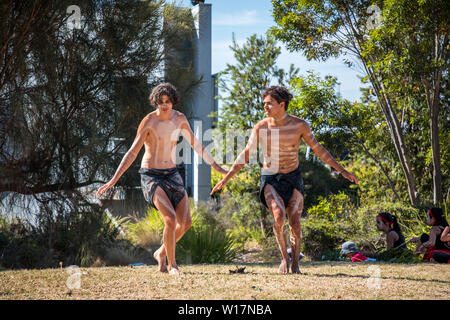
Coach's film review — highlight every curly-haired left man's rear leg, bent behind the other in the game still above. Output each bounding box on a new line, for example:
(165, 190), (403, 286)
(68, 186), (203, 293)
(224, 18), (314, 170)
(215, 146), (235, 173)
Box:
(153, 194), (192, 272)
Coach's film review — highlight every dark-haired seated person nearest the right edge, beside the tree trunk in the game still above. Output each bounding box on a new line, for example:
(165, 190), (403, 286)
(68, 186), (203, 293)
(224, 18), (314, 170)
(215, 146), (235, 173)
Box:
(411, 208), (450, 263)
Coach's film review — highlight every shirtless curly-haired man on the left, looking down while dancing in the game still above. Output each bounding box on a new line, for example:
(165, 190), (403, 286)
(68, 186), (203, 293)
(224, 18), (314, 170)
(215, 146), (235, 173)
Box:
(97, 83), (227, 274)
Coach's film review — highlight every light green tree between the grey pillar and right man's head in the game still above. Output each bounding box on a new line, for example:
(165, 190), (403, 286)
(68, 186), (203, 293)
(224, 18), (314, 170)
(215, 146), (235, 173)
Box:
(218, 34), (298, 132)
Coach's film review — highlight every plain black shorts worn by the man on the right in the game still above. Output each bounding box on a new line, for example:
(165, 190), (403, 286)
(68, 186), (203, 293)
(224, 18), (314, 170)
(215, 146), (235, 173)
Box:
(259, 166), (305, 208)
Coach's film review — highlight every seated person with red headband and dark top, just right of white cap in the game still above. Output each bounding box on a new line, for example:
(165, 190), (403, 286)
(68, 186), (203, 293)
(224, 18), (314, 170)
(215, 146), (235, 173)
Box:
(376, 212), (406, 253)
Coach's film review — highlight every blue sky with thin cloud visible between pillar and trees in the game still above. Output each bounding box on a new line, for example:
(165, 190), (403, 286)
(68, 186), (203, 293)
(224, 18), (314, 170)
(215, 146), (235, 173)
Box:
(176, 0), (363, 101)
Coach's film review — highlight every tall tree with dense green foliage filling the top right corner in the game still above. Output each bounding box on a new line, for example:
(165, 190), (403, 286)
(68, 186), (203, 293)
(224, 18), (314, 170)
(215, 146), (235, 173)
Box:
(364, 0), (450, 206)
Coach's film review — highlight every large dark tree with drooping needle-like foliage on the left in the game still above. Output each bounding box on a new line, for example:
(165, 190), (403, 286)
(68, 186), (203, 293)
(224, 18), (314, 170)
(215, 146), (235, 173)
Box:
(0, 0), (198, 200)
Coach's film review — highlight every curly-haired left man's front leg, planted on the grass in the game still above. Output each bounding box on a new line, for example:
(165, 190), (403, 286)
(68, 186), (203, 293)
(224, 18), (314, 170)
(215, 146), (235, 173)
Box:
(153, 187), (180, 274)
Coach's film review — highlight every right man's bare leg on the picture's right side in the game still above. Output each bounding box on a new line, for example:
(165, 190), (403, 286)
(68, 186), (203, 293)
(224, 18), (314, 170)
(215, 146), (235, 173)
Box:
(286, 189), (303, 274)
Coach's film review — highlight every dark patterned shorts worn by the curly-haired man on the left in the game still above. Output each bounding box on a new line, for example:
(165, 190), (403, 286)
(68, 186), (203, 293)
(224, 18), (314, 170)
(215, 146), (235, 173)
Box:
(139, 167), (186, 210)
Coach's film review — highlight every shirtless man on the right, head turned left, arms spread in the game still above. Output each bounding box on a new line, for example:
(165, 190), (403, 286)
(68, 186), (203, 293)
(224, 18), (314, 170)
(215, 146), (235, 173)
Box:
(211, 86), (358, 273)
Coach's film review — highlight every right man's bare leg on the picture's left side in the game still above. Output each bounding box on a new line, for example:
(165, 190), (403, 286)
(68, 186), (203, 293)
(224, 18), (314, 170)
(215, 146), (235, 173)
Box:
(264, 184), (289, 274)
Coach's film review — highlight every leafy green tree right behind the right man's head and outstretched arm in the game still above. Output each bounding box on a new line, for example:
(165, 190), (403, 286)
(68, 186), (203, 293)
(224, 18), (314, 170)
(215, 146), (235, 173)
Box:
(289, 71), (401, 201)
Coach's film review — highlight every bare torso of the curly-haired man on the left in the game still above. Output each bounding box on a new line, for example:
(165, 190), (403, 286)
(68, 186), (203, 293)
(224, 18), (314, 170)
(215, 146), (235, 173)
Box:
(141, 110), (186, 169)
